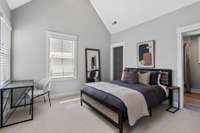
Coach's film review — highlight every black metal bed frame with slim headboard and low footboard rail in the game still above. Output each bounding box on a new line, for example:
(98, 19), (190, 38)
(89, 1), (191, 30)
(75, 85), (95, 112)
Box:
(80, 68), (172, 133)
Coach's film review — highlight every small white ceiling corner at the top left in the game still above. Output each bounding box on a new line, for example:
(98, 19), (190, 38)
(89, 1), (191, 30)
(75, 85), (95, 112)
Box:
(7, 0), (32, 10)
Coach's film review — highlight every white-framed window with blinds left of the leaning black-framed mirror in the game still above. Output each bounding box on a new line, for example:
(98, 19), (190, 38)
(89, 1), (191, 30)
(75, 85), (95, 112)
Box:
(47, 32), (77, 78)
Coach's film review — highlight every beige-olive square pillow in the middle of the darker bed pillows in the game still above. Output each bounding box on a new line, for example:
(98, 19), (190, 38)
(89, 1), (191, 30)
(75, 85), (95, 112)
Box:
(138, 72), (150, 85)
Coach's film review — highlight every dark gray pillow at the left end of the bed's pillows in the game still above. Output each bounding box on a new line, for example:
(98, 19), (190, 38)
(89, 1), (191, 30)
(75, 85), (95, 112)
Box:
(121, 69), (138, 84)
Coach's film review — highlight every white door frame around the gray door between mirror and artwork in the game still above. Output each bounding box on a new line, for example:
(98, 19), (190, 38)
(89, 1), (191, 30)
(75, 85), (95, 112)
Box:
(110, 42), (126, 80)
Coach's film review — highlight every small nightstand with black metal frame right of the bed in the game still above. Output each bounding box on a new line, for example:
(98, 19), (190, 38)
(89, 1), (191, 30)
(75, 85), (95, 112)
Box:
(166, 86), (180, 113)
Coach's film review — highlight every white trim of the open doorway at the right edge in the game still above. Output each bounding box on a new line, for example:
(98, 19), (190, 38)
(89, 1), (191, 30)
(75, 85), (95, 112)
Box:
(177, 23), (200, 108)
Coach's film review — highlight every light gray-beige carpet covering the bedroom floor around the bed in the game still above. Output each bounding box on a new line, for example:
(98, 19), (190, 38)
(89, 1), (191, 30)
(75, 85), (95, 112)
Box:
(0, 96), (200, 133)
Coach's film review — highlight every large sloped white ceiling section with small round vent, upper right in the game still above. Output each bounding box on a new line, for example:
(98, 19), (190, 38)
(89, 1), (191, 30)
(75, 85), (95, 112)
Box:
(90, 0), (200, 34)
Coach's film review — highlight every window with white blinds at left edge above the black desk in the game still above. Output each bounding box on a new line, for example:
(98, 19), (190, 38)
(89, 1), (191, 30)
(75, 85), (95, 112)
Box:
(0, 17), (11, 87)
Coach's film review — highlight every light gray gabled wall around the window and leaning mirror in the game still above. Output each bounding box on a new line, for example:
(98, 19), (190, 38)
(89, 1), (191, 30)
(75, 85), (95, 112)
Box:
(12, 0), (110, 95)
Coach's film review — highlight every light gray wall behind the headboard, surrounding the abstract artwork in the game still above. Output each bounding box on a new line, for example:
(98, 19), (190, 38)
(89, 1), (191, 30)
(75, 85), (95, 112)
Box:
(111, 3), (200, 104)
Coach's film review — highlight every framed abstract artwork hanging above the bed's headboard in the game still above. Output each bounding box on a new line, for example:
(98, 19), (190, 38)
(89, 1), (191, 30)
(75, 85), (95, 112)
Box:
(137, 40), (155, 68)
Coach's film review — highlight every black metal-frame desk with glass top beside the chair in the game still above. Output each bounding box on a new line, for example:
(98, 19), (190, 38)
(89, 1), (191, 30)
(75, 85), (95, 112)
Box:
(0, 80), (34, 128)
